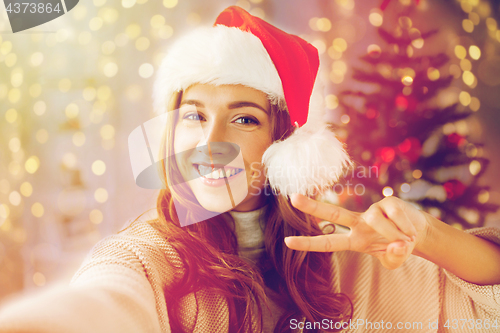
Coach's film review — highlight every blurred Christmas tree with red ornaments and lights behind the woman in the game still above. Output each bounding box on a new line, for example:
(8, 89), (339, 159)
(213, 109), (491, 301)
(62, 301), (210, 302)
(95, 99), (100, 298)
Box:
(336, 12), (498, 229)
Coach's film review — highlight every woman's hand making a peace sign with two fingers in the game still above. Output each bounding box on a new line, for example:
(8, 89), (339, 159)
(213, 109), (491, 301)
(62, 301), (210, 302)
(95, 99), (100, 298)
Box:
(285, 194), (430, 269)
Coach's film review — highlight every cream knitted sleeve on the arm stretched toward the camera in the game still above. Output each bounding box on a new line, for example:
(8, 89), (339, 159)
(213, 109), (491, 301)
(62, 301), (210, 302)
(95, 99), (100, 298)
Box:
(0, 220), (176, 333)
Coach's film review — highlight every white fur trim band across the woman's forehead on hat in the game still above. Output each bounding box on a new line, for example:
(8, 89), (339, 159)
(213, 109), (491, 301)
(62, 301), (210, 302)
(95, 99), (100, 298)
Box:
(153, 25), (286, 114)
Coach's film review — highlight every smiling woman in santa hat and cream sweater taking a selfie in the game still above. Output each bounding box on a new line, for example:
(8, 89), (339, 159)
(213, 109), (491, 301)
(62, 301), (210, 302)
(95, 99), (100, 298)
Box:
(0, 7), (500, 332)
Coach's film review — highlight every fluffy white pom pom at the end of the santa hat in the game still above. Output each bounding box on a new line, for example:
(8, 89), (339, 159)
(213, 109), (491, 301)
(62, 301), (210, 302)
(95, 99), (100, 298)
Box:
(262, 123), (353, 197)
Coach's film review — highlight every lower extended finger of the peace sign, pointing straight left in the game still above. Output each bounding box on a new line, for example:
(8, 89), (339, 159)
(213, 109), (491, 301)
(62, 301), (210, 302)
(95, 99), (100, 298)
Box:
(285, 234), (350, 252)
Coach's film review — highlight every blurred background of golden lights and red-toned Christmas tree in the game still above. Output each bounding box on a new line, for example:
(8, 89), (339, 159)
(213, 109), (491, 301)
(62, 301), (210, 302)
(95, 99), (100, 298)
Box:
(0, 0), (500, 302)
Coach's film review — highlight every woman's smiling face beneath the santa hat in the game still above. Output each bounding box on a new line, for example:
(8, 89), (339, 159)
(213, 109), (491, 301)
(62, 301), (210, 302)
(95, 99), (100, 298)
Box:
(174, 84), (273, 212)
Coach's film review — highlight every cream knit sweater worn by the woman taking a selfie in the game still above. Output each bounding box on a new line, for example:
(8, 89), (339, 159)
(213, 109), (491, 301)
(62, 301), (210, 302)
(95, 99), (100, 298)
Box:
(0, 208), (500, 333)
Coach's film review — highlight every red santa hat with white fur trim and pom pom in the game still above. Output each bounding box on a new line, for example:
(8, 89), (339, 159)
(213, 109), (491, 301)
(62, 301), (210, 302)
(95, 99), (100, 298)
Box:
(153, 6), (352, 196)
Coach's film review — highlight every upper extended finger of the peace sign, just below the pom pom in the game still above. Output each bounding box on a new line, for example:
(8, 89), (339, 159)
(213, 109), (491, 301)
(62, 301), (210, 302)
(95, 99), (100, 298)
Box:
(290, 193), (359, 227)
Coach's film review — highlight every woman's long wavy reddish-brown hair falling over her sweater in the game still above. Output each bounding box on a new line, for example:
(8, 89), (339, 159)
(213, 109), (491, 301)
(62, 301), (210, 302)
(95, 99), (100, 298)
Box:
(150, 92), (353, 332)
